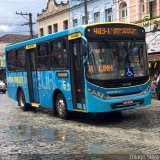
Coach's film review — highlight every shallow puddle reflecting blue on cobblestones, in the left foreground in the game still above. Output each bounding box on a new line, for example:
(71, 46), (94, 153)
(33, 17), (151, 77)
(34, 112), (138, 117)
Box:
(9, 126), (77, 142)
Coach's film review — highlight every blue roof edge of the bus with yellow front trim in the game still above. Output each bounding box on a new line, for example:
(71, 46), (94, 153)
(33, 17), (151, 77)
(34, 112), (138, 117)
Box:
(5, 22), (143, 51)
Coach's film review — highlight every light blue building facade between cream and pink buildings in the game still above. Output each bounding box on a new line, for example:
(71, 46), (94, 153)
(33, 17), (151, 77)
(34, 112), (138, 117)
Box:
(70, 0), (117, 27)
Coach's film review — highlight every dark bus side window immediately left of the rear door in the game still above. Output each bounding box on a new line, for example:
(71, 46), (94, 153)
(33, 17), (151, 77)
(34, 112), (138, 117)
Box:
(16, 48), (26, 71)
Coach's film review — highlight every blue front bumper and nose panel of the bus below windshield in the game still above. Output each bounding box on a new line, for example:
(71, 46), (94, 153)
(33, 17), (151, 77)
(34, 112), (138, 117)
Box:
(85, 81), (151, 112)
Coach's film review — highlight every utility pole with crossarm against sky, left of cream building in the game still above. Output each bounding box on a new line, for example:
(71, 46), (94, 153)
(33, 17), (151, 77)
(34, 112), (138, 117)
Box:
(16, 12), (35, 38)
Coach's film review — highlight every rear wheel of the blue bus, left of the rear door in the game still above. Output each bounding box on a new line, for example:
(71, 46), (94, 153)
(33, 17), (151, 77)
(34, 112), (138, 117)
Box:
(18, 90), (28, 111)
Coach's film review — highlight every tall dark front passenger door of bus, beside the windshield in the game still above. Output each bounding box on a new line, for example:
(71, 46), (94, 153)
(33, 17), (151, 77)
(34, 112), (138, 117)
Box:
(69, 39), (85, 110)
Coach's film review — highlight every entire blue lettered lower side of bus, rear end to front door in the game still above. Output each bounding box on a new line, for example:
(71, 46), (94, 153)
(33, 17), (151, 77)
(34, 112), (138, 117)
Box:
(7, 70), (73, 110)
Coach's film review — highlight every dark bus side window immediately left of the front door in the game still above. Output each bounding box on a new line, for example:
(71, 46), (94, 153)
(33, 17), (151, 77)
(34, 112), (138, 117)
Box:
(49, 38), (68, 68)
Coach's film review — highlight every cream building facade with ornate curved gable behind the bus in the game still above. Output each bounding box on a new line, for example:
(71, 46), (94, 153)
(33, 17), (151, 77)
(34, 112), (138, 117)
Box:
(37, 0), (69, 37)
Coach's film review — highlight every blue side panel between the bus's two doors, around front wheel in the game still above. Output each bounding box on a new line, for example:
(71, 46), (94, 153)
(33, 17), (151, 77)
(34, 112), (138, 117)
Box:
(37, 70), (73, 110)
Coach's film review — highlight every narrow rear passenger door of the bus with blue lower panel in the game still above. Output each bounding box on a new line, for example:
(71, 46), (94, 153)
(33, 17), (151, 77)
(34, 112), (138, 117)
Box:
(26, 49), (39, 103)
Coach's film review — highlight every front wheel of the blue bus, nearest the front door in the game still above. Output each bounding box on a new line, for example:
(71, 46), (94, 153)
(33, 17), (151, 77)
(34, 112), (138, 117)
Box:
(53, 90), (69, 119)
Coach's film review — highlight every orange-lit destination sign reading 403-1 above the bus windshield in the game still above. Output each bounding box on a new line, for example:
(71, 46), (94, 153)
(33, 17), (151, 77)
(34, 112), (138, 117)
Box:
(86, 24), (145, 39)
